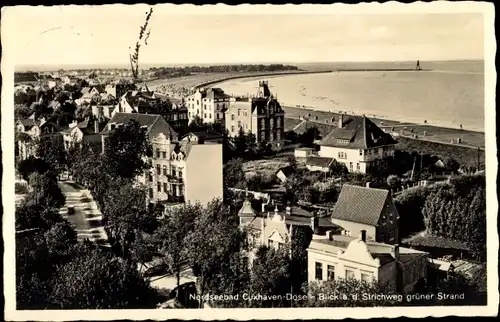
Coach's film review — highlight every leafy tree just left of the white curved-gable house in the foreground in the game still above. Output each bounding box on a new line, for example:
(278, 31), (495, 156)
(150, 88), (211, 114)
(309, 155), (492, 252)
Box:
(250, 246), (292, 307)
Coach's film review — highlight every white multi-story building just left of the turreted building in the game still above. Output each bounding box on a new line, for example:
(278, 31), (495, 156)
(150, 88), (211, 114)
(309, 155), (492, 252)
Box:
(186, 88), (231, 124)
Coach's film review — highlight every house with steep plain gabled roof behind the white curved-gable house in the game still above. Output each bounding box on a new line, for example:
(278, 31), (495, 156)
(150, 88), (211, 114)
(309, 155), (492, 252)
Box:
(331, 184), (399, 244)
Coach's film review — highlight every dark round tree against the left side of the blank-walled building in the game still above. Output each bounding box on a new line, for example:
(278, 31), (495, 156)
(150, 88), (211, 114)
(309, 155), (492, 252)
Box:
(103, 120), (153, 179)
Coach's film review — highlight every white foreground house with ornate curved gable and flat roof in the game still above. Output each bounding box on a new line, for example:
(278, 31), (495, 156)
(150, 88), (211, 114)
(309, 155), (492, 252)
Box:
(307, 231), (428, 293)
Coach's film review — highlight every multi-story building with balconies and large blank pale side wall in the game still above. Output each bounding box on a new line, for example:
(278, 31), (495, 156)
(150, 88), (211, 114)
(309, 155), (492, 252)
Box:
(101, 113), (223, 206)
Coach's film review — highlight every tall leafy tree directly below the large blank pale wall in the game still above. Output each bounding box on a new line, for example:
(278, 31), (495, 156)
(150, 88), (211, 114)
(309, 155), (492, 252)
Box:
(185, 200), (243, 305)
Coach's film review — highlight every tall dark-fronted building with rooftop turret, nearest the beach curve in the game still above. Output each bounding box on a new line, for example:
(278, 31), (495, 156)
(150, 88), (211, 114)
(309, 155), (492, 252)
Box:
(226, 81), (285, 148)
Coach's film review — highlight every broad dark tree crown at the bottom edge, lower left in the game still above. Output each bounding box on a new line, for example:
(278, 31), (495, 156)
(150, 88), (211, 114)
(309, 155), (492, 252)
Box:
(50, 250), (156, 309)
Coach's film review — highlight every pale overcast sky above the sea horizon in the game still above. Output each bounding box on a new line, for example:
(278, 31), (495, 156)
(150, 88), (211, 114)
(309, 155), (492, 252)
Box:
(2, 5), (484, 65)
